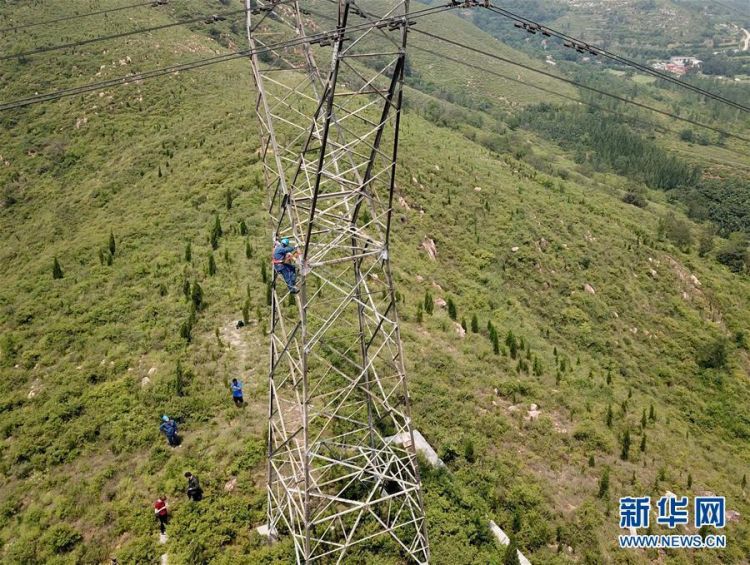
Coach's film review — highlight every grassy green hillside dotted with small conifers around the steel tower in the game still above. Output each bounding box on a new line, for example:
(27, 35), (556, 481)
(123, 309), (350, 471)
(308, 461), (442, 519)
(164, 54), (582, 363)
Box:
(0, 0), (750, 565)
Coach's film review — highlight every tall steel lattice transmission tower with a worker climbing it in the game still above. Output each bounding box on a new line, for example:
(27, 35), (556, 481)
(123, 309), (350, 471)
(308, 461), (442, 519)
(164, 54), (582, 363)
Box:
(246, 0), (429, 563)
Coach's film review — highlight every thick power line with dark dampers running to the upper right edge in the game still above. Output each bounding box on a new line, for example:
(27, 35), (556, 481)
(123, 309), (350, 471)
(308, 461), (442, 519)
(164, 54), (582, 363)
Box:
(488, 6), (750, 112)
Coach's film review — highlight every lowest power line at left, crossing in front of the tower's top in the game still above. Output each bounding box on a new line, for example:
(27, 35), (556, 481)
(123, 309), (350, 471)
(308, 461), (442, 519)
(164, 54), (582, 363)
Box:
(0, 5), (453, 111)
